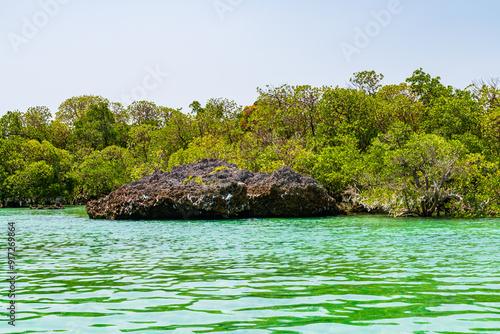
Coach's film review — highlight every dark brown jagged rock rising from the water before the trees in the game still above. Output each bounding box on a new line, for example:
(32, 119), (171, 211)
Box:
(86, 159), (339, 219)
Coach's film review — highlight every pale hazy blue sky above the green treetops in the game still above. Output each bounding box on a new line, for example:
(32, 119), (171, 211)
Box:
(0, 0), (500, 114)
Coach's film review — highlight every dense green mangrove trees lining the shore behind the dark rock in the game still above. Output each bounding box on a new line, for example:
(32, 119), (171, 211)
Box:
(0, 69), (500, 217)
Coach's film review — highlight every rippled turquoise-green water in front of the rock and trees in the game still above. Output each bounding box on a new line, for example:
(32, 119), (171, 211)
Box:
(0, 207), (500, 333)
